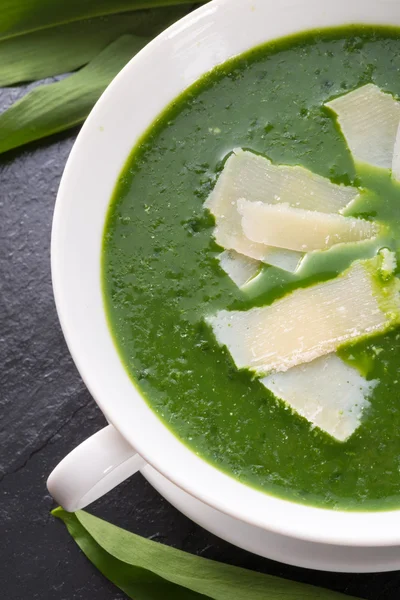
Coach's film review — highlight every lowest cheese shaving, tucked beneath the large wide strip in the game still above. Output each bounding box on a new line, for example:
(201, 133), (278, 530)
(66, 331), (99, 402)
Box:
(261, 354), (379, 442)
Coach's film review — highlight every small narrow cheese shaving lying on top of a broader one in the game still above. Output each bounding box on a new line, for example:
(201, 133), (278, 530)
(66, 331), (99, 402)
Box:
(238, 199), (379, 252)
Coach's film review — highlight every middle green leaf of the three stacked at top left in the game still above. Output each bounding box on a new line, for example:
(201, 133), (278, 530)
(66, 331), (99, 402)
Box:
(0, 6), (188, 87)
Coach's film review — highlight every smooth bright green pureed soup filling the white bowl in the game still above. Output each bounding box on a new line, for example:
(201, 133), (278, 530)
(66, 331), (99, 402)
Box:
(103, 27), (400, 510)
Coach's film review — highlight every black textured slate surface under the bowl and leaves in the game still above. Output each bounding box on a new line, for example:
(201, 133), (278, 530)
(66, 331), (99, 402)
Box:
(0, 90), (400, 600)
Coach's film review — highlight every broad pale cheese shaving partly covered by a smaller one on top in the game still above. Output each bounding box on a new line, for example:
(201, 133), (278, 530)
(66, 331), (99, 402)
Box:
(204, 149), (359, 272)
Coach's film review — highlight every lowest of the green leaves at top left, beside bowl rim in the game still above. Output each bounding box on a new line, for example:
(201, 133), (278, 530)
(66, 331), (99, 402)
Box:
(0, 35), (149, 153)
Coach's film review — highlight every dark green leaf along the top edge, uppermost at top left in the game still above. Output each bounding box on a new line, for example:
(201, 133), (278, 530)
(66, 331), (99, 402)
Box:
(0, 0), (200, 37)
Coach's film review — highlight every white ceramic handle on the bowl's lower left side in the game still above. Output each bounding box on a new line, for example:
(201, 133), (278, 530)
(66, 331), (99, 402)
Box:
(47, 425), (146, 512)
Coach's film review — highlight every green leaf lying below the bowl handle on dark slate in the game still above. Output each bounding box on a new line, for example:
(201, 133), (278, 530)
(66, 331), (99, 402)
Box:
(52, 508), (360, 600)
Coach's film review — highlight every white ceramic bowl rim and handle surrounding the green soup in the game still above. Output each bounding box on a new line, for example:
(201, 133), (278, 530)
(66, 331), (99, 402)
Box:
(48, 0), (400, 547)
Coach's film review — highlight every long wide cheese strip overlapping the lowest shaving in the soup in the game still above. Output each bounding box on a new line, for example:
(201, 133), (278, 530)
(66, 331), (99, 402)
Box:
(207, 258), (400, 375)
